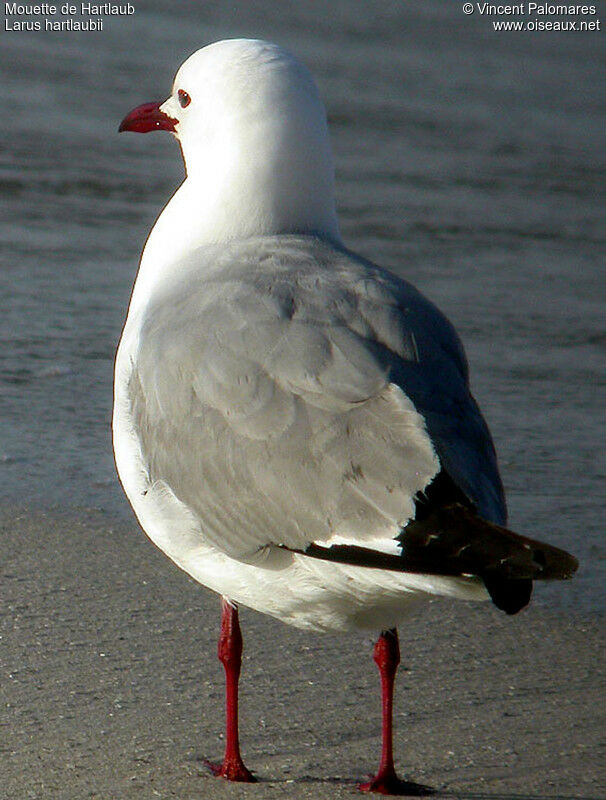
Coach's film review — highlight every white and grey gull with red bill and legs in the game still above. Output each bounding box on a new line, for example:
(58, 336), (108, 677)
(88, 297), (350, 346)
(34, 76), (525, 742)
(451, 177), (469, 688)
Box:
(113, 39), (577, 795)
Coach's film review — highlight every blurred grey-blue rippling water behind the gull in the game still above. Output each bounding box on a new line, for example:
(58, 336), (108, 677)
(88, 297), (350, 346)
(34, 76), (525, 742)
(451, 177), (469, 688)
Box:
(0, 0), (606, 609)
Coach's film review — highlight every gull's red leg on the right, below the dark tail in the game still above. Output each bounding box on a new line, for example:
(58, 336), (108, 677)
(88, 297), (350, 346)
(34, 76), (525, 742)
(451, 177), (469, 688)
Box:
(359, 628), (433, 796)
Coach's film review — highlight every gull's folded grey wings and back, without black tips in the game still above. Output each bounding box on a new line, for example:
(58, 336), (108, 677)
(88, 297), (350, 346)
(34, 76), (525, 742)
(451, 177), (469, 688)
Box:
(129, 241), (508, 559)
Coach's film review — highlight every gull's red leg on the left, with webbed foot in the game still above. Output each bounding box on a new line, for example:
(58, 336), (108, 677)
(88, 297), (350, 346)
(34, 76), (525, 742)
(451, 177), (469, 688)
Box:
(207, 598), (256, 783)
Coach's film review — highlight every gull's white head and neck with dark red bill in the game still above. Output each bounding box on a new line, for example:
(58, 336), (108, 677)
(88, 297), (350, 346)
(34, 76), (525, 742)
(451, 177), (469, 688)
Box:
(121, 39), (339, 241)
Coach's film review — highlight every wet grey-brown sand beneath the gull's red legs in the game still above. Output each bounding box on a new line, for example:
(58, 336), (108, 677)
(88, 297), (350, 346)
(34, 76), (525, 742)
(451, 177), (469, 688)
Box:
(0, 509), (606, 800)
